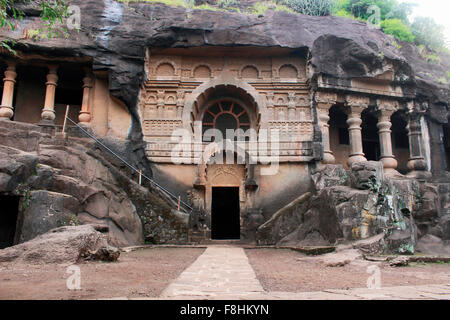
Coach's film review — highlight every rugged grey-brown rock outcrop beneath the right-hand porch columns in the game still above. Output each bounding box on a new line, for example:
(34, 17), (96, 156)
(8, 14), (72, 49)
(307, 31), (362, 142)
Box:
(257, 162), (437, 254)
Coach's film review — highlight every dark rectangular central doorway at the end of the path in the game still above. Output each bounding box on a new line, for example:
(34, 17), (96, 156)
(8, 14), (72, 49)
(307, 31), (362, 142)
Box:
(211, 188), (241, 240)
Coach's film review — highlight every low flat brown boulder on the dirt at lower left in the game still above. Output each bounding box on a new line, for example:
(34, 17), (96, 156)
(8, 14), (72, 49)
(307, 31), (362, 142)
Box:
(0, 225), (119, 264)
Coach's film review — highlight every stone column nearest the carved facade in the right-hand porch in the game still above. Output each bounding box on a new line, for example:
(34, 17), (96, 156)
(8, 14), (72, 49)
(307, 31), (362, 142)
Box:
(316, 92), (337, 164)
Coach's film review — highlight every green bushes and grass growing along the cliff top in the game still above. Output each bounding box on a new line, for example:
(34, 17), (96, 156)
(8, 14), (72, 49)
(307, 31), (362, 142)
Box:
(118, 0), (448, 51)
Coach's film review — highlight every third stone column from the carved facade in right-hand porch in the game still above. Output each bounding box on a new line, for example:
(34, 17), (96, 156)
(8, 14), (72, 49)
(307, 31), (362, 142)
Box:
(377, 100), (398, 172)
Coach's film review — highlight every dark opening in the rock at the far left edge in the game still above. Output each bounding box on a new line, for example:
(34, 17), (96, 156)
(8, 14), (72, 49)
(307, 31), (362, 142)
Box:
(0, 196), (20, 249)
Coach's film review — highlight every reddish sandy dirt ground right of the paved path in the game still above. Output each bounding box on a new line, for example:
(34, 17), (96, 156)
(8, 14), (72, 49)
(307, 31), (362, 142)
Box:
(246, 249), (450, 292)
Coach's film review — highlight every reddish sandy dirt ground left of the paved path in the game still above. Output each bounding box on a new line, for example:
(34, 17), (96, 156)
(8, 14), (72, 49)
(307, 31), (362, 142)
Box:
(0, 248), (204, 300)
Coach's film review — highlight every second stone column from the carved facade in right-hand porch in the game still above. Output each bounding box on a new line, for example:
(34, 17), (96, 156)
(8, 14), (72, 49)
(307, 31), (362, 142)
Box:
(346, 96), (369, 167)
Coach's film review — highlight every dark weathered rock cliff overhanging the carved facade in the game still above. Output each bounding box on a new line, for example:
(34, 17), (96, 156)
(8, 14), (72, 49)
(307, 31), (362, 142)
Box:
(0, 0), (450, 139)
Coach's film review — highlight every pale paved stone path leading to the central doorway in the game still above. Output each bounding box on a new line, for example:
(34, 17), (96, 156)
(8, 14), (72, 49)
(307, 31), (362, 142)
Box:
(159, 246), (450, 300)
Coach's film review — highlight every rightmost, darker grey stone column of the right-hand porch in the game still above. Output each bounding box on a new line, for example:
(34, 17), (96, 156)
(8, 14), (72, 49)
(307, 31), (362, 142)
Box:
(407, 112), (431, 178)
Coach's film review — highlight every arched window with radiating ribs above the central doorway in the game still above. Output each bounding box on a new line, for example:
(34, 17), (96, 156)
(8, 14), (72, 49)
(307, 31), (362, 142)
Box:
(202, 100), (250, 141)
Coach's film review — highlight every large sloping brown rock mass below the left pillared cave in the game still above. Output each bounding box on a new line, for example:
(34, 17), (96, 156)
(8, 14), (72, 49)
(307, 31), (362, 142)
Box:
(0, 122), (188, 247)
